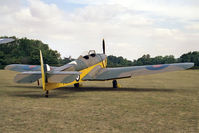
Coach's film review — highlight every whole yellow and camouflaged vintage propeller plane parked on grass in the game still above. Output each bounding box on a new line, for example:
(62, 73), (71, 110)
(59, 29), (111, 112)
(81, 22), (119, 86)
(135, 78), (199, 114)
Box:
(5, 39), (194, 97)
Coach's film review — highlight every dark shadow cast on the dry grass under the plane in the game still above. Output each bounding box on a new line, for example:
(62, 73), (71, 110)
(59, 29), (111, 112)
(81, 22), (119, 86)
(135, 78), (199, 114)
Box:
(10, 86), (179, 98)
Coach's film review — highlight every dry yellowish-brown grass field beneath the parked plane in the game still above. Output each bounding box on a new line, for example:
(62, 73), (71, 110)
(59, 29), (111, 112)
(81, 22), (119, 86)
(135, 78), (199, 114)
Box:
(0, 70), (199, 133)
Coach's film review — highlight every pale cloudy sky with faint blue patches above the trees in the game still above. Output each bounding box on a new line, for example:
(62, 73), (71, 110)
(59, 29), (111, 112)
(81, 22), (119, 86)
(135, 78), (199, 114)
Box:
(0, 0), (199, 60)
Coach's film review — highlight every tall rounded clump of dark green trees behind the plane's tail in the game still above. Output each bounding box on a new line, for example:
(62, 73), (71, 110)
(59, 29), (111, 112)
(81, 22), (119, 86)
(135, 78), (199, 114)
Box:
(0, 37), (61, 68)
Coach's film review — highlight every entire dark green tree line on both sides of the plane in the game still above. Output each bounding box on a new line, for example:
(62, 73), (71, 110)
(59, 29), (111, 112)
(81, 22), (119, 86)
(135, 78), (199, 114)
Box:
(0, 37), (199, 69)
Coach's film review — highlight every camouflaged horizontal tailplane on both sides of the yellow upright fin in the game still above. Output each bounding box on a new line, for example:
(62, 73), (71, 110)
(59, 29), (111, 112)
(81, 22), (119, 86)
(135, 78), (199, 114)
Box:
(14, 71), (81, 83)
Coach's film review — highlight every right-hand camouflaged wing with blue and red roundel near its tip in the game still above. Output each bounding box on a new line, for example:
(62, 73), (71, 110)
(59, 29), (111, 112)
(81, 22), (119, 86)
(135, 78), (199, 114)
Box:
(83, 63), (194, 81)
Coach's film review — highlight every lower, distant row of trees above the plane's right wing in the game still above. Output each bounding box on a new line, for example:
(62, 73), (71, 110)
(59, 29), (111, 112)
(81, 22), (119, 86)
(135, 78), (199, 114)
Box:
(108, 51), (199, 68)
